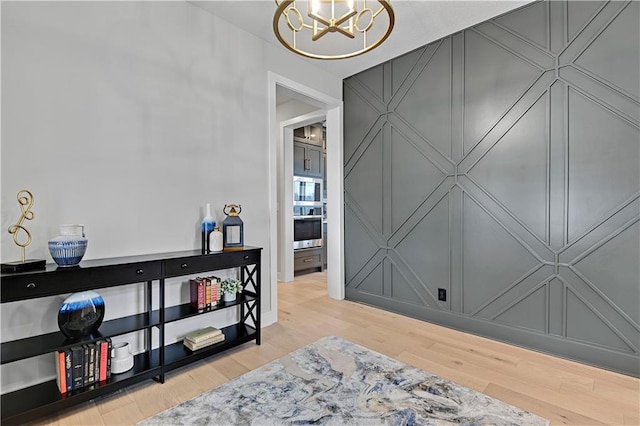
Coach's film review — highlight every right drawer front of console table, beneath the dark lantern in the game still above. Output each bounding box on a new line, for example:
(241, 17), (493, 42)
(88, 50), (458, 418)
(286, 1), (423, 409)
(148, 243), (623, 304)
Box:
(165, 250), (260, 277)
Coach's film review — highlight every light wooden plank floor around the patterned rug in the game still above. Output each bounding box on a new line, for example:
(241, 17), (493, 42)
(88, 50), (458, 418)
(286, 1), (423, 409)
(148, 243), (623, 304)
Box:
(37, 273), (640, 425)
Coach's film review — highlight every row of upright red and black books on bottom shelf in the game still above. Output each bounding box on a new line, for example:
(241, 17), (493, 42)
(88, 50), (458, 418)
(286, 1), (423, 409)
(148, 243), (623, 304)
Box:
(53, 338), (112, 393)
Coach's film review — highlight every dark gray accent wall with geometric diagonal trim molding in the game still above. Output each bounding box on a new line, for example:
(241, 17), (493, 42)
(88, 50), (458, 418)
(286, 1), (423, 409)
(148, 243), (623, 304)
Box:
(343, 1), (640, 376)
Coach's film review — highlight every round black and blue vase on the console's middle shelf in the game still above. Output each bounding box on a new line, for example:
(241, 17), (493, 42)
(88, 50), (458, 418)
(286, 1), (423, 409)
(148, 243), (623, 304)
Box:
(58, 291), (104, 338)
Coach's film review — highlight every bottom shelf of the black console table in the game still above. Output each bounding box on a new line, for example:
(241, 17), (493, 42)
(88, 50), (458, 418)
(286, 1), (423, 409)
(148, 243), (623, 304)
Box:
(0, 324), (259, 424)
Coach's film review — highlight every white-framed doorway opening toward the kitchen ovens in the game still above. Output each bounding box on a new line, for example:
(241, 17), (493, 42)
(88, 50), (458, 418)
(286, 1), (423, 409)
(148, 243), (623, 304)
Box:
(265, 72), (344, 323)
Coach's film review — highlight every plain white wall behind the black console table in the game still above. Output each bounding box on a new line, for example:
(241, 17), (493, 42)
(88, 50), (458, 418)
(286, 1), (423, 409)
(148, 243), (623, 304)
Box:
(0, 2), (342, 392)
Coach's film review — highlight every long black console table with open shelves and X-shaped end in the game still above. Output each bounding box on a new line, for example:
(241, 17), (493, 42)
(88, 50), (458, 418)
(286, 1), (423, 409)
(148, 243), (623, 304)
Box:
(0, 247), (262, 424)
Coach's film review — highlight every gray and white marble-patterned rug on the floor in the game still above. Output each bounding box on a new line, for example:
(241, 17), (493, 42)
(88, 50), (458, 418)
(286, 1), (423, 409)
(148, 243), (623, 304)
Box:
(138, 336), (549, 425)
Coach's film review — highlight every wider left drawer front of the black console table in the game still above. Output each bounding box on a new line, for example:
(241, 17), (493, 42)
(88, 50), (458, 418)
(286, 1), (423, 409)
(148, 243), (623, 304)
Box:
(2, 262), (162, 303)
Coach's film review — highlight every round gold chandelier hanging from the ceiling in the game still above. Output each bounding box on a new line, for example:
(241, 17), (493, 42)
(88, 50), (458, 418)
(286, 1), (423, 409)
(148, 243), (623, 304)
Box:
(273, 0), (395, 59)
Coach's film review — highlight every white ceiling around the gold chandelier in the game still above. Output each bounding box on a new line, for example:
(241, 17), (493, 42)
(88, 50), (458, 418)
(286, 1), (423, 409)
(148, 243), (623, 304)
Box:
(190, 0), (532, 78)
